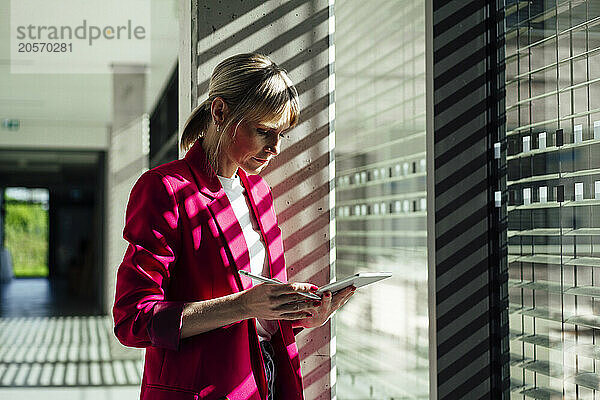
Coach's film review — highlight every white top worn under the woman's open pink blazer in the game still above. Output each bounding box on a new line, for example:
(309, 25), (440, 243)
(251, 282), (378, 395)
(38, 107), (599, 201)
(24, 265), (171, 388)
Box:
(217, 175), (279, 340)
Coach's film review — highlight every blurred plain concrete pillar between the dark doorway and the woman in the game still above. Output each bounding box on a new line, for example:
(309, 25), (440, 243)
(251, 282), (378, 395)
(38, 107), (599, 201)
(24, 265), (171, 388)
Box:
(104, 65), (149, 314)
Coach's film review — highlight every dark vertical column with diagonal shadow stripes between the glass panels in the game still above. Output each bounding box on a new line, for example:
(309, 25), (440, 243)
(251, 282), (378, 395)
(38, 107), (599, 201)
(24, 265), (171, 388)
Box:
(428, 0), (509, 400)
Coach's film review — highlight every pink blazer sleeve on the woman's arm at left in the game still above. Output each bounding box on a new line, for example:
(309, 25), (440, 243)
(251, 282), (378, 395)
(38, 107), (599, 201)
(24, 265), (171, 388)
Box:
(113, 171), (185, 350)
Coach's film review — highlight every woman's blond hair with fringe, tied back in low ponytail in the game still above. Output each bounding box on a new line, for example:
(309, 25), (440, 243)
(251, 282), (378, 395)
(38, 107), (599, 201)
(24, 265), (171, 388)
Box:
(180, 53), (300, 171)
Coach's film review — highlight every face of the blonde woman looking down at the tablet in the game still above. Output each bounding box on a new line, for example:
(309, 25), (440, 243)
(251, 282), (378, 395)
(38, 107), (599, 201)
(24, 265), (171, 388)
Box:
(222, 117), (289, 177)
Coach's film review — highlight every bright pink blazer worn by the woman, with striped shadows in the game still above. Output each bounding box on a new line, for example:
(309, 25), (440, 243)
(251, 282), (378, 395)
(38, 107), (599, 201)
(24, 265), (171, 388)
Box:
(113, 140), (303, 400)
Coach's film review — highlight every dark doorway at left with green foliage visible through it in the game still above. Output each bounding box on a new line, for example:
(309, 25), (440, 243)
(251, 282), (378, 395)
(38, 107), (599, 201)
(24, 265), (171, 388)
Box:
(0, 150), (105, 317)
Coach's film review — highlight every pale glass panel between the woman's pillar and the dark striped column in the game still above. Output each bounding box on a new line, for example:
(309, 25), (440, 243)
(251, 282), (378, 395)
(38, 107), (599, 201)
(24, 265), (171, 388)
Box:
(335, 0), (429, 399)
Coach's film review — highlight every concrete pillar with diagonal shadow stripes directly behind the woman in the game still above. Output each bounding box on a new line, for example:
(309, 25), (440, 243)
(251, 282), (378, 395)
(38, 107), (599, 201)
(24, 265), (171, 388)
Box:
(179, 0), (335, 399)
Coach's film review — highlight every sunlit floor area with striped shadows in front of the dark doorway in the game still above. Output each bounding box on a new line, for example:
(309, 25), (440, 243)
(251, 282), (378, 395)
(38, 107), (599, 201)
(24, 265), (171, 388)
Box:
(0, 316), (142, 388)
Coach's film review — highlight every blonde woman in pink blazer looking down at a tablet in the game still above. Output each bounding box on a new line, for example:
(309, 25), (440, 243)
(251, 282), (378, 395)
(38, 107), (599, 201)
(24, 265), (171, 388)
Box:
(113, 54), (354, 400)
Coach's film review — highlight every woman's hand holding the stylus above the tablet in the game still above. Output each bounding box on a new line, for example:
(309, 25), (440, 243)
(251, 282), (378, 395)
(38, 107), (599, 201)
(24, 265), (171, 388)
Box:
(240, 283), (322, 320)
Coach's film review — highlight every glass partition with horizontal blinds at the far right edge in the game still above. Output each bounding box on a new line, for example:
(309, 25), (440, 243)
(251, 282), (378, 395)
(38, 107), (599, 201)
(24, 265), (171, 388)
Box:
(506, 0), (600, 399)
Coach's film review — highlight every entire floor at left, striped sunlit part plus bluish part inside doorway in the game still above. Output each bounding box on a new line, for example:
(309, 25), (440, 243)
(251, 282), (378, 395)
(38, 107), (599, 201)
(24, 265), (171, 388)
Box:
(0, 279), (143, 400)
